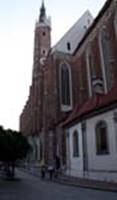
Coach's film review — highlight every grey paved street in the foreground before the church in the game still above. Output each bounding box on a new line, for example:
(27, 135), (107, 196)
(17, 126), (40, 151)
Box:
(0, 172), (117, 200)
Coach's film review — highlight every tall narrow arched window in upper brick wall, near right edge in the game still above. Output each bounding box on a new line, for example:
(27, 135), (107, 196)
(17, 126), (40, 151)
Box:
(100, 29), (113, 92)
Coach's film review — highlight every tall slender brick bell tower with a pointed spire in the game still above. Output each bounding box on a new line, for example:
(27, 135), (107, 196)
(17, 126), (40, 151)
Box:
(30, 1), (51, 138)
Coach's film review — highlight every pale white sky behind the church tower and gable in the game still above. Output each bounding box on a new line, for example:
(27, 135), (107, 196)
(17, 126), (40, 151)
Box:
(0, 0), (106, 130)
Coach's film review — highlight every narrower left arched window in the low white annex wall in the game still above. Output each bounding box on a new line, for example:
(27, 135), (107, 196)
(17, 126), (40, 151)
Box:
(73, 131), (79, 157)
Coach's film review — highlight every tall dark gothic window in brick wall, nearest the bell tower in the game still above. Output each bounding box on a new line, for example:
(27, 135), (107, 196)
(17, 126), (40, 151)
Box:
(60, 63), (72, 111)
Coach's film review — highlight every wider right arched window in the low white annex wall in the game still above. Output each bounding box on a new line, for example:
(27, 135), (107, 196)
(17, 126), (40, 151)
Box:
(95, 121), (109, 155)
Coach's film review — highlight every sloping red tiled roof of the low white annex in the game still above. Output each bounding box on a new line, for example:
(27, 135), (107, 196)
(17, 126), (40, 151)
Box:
(62, 84), (117, 126)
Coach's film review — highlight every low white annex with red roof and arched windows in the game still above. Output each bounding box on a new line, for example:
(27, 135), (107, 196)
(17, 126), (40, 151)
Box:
(64, 86), (117, 182)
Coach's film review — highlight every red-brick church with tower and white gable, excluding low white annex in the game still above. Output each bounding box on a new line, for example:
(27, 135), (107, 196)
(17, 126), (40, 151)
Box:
(20, 0), (117, 170)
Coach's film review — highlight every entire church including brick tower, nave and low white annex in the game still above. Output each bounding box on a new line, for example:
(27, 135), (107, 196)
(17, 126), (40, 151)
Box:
(20, 0), (117, 181)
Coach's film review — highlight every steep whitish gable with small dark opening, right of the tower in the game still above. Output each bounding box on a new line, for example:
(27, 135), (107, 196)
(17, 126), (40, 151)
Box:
(52, 10), (93, 54)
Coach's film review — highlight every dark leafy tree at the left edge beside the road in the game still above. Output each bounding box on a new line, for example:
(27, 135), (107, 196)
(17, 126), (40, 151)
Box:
(0, 127), (31, 177)
